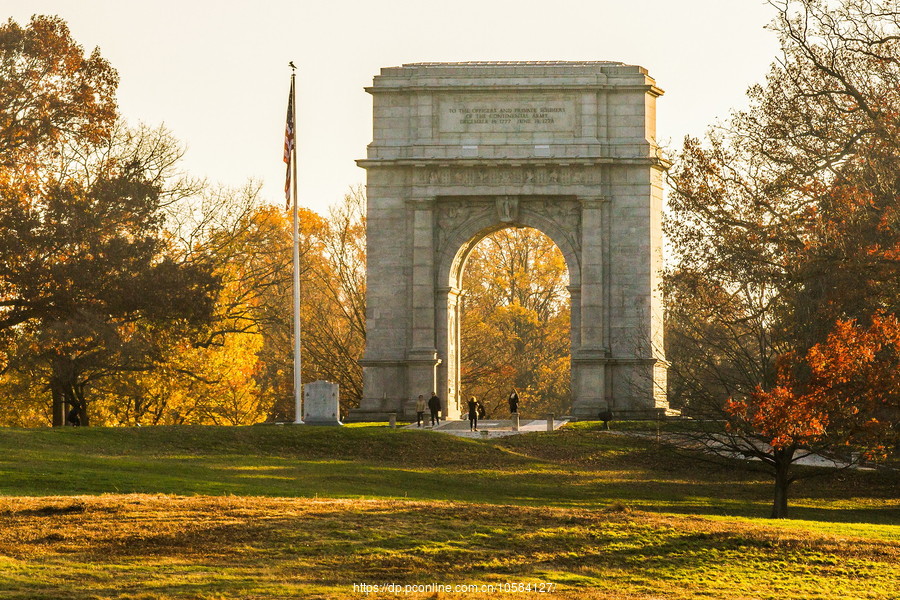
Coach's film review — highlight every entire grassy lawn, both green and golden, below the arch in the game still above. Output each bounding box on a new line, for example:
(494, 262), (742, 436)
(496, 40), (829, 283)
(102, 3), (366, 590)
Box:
(0, 424), (900, 600)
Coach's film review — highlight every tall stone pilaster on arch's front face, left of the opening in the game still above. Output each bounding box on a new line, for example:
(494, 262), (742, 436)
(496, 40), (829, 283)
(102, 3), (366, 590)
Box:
(403, 198), (440, 417)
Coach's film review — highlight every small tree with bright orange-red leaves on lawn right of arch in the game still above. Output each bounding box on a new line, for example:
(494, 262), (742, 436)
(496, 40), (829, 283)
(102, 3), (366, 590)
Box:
(720, 314), (900, 517)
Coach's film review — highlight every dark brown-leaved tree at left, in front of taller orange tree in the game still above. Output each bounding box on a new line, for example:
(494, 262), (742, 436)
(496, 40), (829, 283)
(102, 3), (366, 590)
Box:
(0, 124), (218, 424)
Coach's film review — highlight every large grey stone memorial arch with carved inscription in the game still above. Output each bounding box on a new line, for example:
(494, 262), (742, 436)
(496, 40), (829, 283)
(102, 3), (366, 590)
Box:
(349, 62), (666, 421)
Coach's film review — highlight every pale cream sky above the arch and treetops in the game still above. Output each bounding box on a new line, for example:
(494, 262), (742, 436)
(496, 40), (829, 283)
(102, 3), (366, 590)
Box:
(0, 0), (778, 213)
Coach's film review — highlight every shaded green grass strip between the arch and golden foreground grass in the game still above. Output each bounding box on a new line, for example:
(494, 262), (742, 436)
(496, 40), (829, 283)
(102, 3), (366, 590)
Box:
(0, 425), (900, 523)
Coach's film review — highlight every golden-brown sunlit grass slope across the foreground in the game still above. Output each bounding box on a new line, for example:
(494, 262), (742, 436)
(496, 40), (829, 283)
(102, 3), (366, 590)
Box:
(0, 495), (900, 600)
